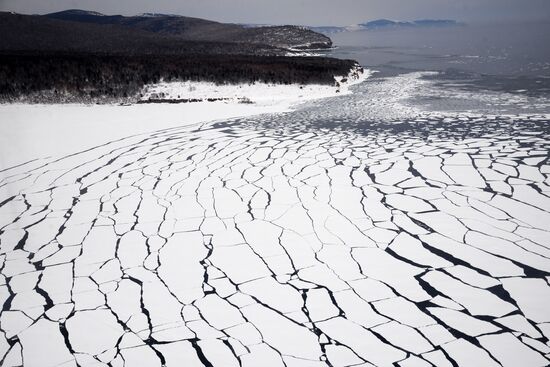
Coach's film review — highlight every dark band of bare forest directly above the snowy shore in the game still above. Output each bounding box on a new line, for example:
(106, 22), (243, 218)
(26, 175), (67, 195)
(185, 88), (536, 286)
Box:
(0, 52), (356, 102)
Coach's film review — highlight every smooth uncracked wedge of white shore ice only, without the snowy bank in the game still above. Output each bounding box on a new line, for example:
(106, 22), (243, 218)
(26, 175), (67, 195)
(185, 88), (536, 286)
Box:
(0, 102), (289, 169)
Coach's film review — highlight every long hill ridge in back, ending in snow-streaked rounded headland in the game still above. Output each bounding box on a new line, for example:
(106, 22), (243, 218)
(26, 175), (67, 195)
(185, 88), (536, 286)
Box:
(43, 9), (332, 50)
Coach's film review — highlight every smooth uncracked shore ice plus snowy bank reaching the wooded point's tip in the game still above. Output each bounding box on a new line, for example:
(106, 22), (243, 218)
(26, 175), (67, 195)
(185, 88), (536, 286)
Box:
(0, 70), (372, 170)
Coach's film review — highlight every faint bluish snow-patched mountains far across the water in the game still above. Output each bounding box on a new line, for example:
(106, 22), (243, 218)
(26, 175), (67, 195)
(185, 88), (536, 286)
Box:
(309, 19), (463, 35)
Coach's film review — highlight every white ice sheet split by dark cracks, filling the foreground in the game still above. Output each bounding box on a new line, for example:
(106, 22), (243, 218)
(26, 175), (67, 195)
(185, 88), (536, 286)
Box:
(0, 75), (550, 367)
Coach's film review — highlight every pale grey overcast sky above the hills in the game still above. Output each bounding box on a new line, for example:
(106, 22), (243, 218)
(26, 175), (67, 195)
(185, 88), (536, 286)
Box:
(0, 0), (550, 25)
